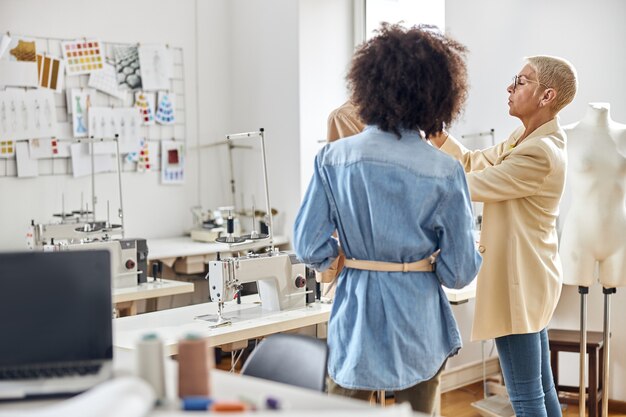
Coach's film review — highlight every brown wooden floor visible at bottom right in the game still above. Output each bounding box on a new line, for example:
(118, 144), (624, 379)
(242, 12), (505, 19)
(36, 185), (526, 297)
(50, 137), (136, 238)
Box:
(441, 382), (626, 417)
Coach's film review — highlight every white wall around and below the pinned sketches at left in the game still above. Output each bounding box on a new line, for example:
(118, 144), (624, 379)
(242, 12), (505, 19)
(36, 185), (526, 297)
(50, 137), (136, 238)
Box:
(0, 0), (212, 250)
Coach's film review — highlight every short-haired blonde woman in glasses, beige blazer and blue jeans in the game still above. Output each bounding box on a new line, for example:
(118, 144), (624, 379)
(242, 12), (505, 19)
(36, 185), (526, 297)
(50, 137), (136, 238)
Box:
(431, 56), (577, 417)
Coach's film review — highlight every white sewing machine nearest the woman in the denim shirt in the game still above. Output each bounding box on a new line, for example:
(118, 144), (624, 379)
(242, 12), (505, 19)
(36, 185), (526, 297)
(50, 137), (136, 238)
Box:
(207, 251), (307, 316)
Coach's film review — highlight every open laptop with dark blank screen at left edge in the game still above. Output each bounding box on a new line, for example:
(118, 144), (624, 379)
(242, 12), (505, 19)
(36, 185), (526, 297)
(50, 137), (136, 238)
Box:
(0, 250), (113, 400)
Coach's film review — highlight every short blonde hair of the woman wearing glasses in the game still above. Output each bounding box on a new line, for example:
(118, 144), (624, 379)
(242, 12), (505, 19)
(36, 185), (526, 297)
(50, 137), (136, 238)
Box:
(525, 55), (578, 113)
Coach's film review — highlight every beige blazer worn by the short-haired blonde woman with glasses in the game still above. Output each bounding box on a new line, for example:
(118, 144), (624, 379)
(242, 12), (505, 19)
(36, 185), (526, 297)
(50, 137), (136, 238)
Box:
(441, 118), (567, 340)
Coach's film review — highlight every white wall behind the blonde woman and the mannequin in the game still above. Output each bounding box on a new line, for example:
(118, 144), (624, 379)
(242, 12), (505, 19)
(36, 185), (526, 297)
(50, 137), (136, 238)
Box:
(446, 0), (626, 401)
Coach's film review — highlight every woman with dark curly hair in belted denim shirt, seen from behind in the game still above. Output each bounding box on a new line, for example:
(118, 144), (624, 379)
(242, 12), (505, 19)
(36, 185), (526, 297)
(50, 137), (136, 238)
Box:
(294, 24), (481, 413)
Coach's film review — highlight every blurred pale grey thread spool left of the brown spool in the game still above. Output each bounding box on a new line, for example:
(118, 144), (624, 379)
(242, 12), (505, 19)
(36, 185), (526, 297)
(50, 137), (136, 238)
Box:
(137, 333), (166, 402)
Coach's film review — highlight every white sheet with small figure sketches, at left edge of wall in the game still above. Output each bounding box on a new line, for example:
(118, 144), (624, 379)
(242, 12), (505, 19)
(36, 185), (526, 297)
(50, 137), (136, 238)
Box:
(0, 89), (57, 140)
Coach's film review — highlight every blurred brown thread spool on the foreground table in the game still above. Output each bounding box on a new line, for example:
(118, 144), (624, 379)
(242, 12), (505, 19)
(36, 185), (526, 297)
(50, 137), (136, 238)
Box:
(178, 335), (215, 398)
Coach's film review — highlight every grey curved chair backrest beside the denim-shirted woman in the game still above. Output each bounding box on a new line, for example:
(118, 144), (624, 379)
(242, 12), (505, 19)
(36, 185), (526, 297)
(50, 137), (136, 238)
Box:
(241, 333), (328, 392)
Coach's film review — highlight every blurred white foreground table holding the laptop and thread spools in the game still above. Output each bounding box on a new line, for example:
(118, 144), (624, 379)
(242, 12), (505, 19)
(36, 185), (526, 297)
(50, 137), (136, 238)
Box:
(0, 349), (426, 417)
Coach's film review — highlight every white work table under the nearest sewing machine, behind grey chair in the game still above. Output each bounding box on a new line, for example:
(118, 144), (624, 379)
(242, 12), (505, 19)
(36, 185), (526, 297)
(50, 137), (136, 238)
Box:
(113, 295), (332, 355)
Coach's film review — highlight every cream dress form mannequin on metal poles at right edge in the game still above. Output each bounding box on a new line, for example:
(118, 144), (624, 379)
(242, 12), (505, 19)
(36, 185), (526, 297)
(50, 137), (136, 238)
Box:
(560, 103), (626, 416)
